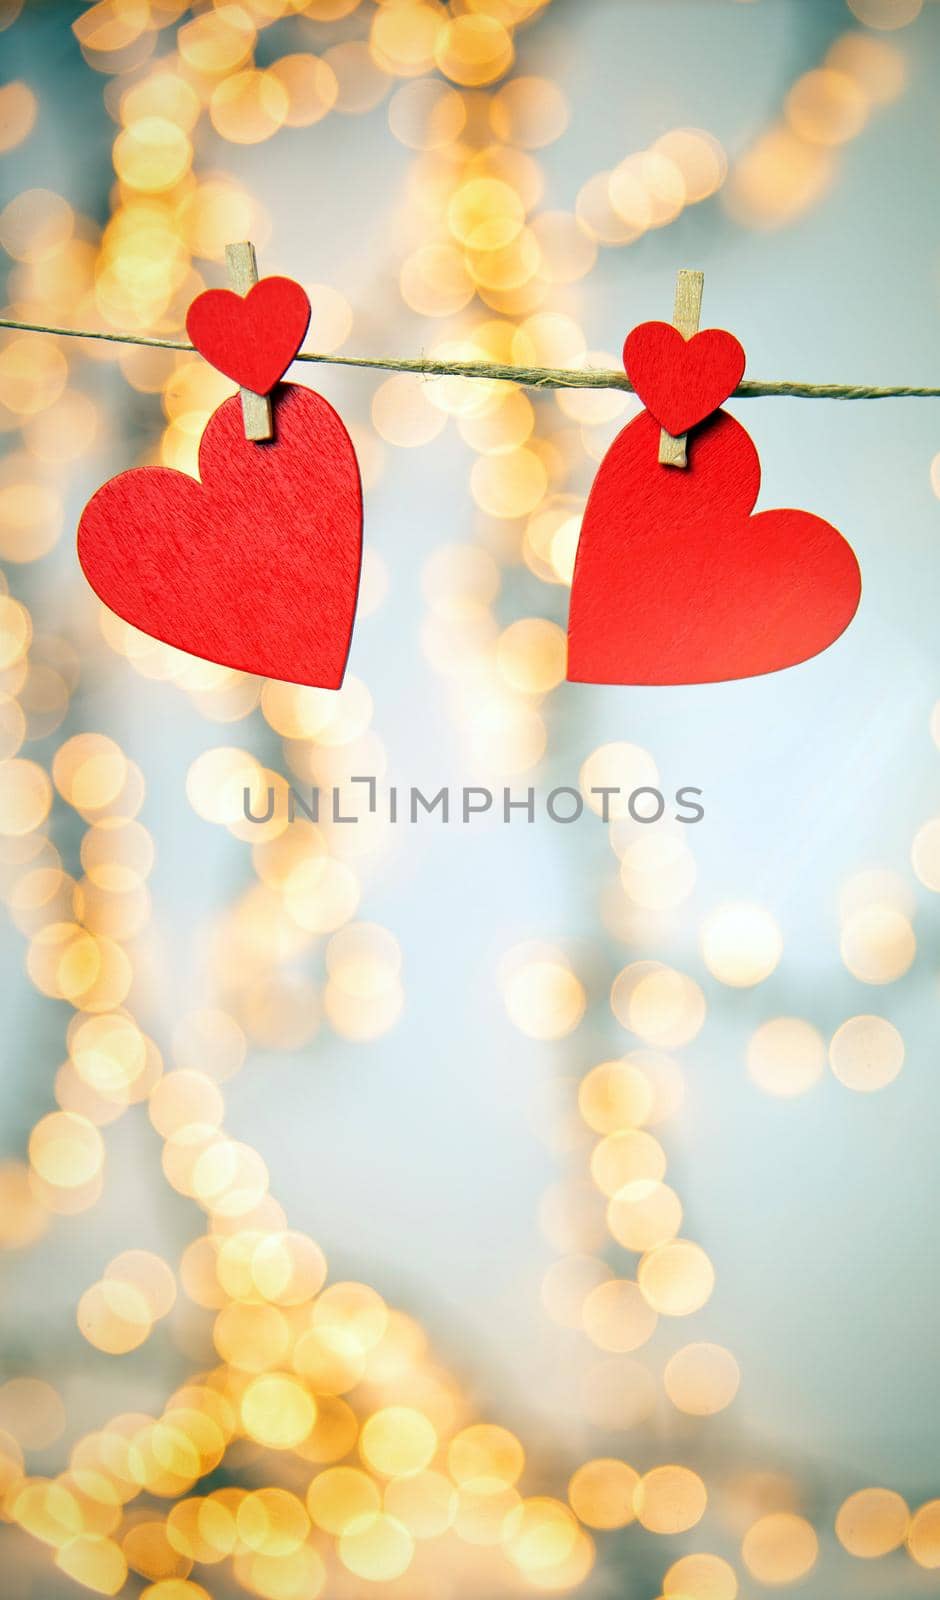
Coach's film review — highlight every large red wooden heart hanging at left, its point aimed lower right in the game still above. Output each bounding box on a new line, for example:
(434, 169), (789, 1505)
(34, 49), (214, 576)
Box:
(78, 384), (363, 690)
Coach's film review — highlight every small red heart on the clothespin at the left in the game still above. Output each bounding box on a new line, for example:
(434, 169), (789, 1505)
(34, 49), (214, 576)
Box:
(185, 278), (310, 395)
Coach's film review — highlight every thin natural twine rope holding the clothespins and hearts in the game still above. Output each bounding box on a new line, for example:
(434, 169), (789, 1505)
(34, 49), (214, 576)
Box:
(0, 317), (940, 400)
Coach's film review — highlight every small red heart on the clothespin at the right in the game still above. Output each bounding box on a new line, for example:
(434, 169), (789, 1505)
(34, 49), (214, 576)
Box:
(623, 322), (745, 437)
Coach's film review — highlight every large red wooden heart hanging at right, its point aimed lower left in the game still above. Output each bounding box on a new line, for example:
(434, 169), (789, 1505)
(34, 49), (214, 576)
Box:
(568, 411), (862, 683)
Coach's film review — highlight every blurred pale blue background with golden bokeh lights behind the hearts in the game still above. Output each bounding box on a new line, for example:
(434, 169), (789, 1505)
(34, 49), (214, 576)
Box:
(0, 0), (940, 1600)
